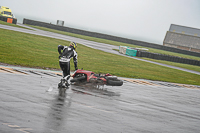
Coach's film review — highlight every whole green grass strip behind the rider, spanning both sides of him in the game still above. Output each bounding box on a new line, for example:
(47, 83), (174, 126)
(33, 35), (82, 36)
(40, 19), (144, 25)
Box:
(0, 29), (200, 85)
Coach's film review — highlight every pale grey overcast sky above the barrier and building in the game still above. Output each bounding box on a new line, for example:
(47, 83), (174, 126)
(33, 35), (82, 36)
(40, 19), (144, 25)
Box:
(0, 0), (200, 45)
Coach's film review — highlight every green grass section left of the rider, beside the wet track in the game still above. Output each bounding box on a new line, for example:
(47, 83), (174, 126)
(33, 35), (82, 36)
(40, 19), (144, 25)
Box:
(0, 29), (60, 68)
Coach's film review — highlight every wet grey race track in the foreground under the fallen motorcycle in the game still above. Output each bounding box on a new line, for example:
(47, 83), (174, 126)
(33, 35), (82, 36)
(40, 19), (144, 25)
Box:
(0, 66), (200, 133)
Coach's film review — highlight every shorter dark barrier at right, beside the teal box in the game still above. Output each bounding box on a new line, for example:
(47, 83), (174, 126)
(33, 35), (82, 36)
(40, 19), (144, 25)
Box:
(137, 50), (200, 66)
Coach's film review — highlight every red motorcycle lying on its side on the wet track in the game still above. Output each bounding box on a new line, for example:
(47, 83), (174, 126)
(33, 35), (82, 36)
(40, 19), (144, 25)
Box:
(70, 69), (123, 86)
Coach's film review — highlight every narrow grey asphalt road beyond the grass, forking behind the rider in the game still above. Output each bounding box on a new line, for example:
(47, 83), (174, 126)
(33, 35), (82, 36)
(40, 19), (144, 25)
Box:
(0, 23), (200, 75)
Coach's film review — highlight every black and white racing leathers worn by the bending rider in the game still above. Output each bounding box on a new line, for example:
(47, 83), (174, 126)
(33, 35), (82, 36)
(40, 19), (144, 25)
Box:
(58, 45), (78, 77)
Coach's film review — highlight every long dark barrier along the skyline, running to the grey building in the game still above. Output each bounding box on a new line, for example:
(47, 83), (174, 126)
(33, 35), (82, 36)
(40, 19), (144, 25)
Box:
(23, 18), (200, 57)
